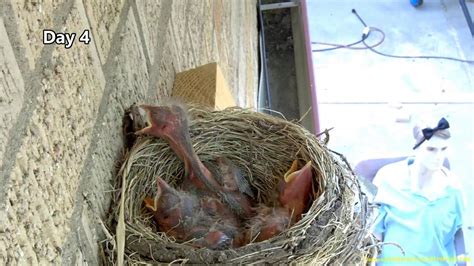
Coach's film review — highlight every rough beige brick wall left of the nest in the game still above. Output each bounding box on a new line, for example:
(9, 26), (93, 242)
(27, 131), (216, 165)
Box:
(0, 0), (258, 265)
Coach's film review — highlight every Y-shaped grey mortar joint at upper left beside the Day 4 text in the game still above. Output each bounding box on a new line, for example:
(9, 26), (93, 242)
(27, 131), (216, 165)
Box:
(0, 0), (74, 213)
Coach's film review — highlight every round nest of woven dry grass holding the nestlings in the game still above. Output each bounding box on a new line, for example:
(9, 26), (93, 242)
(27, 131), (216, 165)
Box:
(107, 107), (376, 265)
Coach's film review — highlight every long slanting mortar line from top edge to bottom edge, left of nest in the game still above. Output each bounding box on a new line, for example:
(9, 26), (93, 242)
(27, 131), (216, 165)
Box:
(61, 0), (131, 265)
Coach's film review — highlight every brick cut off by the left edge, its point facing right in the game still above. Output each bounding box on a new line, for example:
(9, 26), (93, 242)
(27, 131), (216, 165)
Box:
(0, 18), (25, 168)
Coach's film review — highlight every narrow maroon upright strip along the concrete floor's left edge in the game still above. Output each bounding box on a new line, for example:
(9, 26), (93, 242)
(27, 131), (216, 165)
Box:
(301, 0), (321, 134)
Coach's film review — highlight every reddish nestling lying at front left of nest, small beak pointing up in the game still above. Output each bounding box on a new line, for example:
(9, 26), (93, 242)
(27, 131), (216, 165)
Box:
(144, 177), (240, 249)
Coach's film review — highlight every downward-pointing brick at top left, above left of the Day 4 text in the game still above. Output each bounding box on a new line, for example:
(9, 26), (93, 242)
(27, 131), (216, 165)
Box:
(11, 0), (65, 70)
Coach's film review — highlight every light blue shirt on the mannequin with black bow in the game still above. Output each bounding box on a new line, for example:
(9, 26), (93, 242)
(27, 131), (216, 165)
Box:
(374, 161), (464, 265)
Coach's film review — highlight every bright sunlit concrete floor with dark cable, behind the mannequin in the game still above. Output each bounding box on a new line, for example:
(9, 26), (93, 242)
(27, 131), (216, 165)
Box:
(308, 0), (474, 260)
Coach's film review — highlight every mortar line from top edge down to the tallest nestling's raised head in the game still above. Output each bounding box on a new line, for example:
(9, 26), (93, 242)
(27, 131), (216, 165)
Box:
(146, 0), (172, 99)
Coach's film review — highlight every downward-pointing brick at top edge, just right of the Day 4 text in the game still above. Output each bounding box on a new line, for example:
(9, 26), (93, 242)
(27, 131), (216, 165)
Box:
(84, 0), (124, 64)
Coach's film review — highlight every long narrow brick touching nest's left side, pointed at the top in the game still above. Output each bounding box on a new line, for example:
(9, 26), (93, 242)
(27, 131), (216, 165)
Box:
(63, 9), (149, 264)
